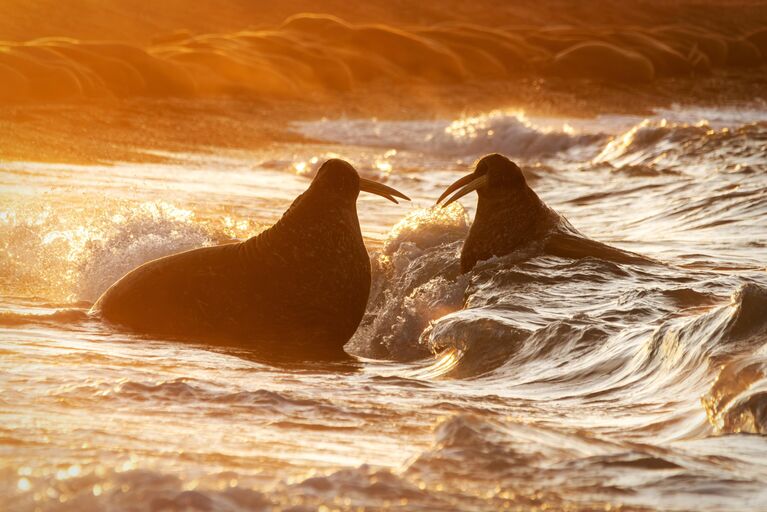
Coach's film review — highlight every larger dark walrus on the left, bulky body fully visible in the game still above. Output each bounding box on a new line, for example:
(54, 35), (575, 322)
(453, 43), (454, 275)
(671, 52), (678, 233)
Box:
(91, 159), (409, 360)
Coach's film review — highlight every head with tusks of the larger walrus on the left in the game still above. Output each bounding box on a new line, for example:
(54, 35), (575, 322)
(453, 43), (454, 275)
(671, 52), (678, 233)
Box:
(311, 158), (410, 203)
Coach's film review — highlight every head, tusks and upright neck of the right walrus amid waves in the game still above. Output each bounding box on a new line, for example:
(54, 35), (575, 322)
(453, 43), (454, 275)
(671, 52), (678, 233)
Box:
(437, 154), (550, 272)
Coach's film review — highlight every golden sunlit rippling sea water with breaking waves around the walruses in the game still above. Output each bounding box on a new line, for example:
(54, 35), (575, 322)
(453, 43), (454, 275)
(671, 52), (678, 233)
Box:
(0, 105), (767, 511)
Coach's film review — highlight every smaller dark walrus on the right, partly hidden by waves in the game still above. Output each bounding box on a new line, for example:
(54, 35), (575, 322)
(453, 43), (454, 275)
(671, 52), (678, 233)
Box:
(437, 154), (653, 272)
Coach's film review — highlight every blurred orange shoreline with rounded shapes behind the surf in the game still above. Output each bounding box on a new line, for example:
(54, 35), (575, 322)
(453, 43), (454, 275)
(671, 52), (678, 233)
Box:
(0, 0), (767, 162)
